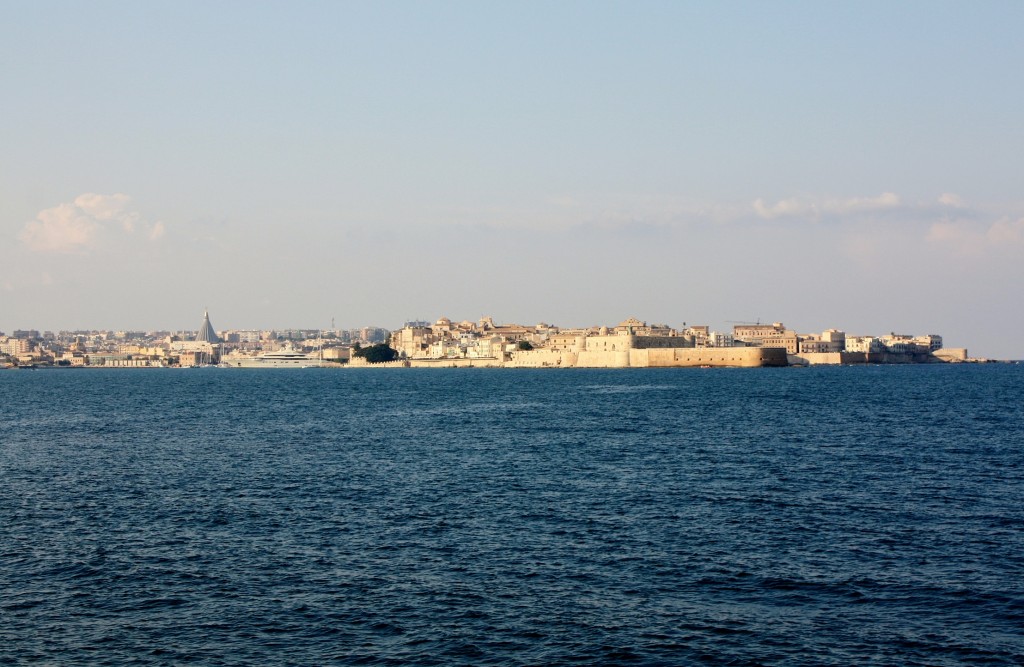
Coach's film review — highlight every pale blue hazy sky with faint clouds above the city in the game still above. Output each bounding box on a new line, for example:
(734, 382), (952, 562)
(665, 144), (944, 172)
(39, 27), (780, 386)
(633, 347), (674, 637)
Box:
(0, 0), (1024, 359)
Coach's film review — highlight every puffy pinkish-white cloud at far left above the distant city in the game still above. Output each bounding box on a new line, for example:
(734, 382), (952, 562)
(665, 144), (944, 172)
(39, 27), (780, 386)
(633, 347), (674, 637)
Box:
(19, 193), (165, 253)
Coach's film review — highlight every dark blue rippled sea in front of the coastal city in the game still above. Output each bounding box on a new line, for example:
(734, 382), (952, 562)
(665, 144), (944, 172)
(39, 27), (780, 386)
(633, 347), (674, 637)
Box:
(0, 365), (1024, 666)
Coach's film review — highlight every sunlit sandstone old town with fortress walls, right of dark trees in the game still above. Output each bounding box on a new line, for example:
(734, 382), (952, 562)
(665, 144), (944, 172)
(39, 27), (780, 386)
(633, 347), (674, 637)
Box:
(378, 318), (967, 368)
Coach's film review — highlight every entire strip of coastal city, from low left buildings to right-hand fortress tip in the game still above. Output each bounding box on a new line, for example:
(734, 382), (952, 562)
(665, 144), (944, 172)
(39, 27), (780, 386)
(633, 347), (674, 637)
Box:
(0, 312), (974, 368)
